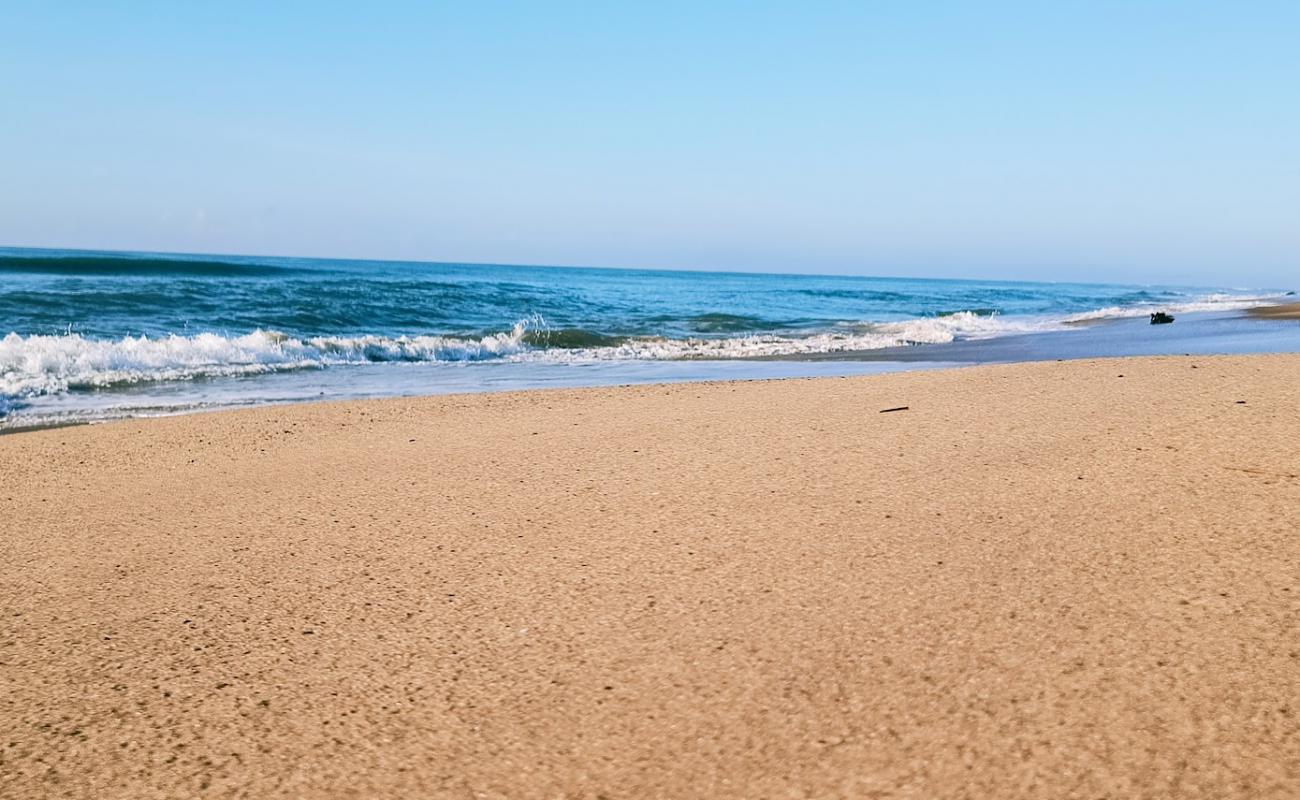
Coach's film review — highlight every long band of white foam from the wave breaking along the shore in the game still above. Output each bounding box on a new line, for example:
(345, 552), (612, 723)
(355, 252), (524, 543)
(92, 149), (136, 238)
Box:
(0, 294), (1281, 405)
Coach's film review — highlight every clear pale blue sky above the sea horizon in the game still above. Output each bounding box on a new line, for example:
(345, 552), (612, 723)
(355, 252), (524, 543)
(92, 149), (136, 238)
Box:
(0, 0), (1300, 286)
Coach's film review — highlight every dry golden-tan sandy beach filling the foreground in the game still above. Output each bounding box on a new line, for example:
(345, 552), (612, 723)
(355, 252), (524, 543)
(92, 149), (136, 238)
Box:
(0, 355), (1300, 799)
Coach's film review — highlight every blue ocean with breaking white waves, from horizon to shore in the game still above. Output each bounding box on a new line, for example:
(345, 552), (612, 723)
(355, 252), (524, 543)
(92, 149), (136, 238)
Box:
(0, 248), (1282, 428)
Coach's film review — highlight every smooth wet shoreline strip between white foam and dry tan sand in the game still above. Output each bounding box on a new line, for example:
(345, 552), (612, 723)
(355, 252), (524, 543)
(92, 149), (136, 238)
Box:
(0, 304), (1300, 436)
